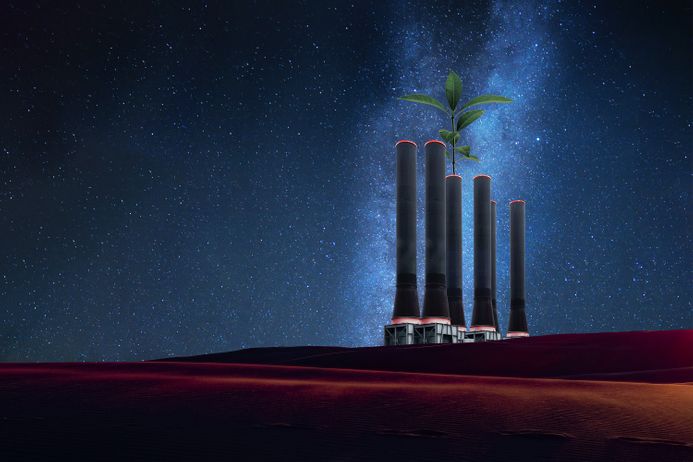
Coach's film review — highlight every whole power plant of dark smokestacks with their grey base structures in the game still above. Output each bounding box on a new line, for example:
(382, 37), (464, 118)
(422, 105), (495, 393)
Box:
(385, 140), (529, 345)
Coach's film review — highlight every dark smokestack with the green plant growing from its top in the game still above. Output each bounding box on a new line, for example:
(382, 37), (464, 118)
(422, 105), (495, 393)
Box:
(445, 175), (466, 330)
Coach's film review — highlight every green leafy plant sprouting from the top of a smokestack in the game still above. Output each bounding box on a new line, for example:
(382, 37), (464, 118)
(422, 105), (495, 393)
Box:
(399, 71), (512, 174)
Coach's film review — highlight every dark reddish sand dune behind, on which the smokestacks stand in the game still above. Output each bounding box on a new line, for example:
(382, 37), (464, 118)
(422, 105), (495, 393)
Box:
(171, 330), (693, 383)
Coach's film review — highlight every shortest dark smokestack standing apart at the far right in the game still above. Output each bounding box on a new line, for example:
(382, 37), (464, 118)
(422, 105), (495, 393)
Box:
(507, 201), (529, 338)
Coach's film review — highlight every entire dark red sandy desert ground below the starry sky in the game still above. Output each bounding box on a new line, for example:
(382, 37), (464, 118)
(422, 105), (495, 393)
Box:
(0, 330), (693, 462)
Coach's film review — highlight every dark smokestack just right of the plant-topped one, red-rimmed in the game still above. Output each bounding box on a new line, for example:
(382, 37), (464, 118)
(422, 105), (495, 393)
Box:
(470, 175), (496, 332)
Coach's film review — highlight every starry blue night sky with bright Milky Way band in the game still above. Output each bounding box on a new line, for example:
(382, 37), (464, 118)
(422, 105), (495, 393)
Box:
(0, 0), (693, 361)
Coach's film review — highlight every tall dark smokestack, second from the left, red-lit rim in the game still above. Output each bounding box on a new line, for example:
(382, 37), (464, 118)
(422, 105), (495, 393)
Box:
(421, 140), (450, 324)
